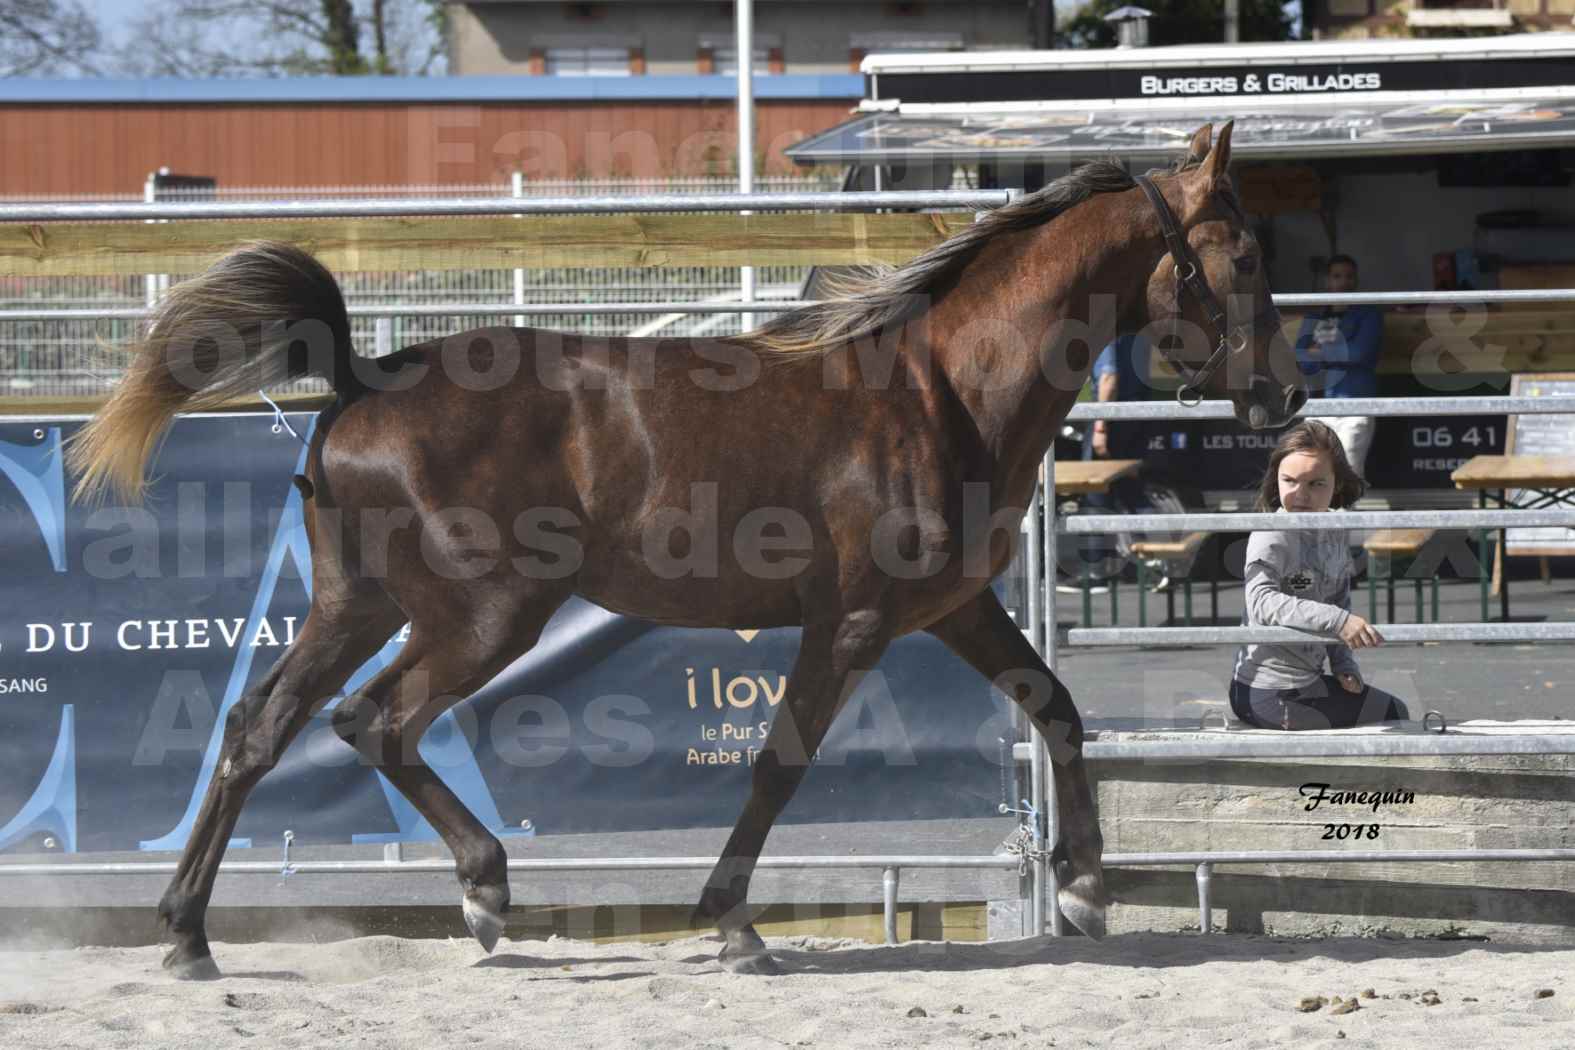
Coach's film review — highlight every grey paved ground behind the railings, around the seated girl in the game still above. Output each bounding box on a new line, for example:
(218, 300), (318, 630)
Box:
(1057, 579), (1575, 729)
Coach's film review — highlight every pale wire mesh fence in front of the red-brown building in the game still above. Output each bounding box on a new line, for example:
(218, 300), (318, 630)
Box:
(0, 175), (838, 398)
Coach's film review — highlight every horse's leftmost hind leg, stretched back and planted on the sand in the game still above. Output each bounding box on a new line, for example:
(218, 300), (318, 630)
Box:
(159, 589), (405, 979)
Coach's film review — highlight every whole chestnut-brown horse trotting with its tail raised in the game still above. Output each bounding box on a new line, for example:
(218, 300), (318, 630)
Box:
(71, 124), (1306, 978)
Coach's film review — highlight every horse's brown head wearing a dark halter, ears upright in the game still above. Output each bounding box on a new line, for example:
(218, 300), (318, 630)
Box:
(1139, 123), (1307, 430)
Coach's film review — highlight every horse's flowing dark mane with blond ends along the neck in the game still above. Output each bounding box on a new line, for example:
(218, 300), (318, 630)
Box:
(748, 157), (1197, 354)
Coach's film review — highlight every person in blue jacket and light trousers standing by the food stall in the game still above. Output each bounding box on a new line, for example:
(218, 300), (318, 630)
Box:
(1296, 255), (1383, 477)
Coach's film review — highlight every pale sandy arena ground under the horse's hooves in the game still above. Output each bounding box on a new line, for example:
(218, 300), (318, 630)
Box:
(0, 934), (1575, 1050)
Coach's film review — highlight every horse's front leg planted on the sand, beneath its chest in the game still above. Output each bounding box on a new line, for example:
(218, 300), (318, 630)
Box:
(696, 611), (890, 973)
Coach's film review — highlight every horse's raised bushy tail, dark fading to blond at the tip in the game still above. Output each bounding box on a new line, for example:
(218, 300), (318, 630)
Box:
(66, 241), (365, 502)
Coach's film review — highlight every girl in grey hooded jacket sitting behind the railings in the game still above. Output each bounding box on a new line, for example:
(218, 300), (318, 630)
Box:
(1230, 420), (1410, 729)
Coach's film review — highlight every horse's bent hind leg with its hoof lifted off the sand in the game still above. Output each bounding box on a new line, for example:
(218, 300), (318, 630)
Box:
(334, 598), (562, 951)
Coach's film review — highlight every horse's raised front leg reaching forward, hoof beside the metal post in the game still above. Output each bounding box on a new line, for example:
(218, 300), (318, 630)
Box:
(926, 587), (1106, 940)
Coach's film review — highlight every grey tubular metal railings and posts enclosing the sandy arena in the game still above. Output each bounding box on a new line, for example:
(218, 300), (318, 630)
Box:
(0, 190), (1575, 941)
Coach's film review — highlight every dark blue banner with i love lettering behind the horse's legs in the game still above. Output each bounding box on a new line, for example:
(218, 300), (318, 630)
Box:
(0, 414), (1011, 853)
